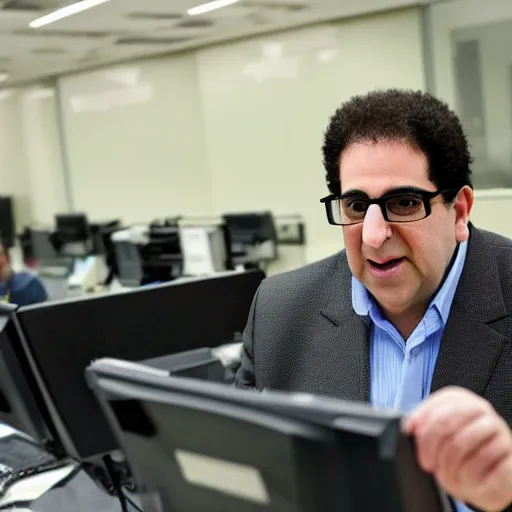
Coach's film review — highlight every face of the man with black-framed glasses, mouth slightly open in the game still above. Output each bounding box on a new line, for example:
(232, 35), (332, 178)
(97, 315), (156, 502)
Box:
(340, 141), (473, 315)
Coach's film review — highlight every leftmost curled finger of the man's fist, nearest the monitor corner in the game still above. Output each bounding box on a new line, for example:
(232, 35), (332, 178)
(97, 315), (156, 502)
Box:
(415, 403), (483, 472)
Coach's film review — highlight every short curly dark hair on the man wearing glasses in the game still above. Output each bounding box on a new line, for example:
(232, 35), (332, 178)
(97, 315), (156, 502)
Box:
(322, 89), (473, 200)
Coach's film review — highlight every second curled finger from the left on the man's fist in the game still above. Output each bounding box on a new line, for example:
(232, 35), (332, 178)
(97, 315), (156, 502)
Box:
(434, 414), (499, 484)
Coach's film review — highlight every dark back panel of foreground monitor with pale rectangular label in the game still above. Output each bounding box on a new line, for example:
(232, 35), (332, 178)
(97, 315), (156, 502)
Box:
(111, 401), (343, 512)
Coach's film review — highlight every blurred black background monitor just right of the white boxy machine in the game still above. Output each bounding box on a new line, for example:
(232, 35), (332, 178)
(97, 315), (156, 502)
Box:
(223, 212), (277, 266)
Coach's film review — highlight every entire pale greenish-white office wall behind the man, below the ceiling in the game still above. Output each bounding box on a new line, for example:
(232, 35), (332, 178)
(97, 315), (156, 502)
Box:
(0, 0), (512, 272)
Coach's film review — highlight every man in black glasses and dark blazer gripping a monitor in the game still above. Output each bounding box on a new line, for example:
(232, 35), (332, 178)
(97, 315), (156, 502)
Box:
(236, 90), (512, 511)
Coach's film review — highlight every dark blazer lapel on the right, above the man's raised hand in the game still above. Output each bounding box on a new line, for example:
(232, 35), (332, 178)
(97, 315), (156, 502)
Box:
(432, 228), (509, 395)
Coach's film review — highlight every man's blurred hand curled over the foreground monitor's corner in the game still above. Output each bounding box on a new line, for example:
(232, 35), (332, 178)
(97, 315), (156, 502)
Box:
(404, 387), (512, 511)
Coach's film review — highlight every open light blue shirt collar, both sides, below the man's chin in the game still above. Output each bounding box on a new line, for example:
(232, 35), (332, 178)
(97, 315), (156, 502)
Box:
(352, 242), (468, 325)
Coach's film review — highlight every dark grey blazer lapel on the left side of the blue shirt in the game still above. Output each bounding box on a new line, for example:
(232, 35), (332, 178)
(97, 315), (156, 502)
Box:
(321, 251), (370, 402)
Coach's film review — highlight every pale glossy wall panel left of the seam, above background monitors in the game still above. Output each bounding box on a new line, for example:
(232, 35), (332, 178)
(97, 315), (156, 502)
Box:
(59, 54), (211, 222)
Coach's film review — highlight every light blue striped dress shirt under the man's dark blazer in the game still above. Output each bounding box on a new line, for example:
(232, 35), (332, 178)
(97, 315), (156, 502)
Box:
(352, 242), (470, 512)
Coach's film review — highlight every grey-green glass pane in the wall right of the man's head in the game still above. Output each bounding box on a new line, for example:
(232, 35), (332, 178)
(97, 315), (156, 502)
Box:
(451, 21), (512, 188)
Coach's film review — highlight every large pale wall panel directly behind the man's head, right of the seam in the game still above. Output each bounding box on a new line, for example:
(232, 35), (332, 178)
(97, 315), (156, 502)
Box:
(197, 10), (424, 261)
